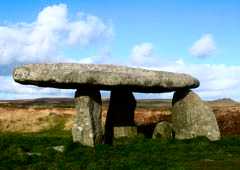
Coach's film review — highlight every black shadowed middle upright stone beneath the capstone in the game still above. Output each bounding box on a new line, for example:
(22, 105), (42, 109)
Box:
(105, 89), (136, 144)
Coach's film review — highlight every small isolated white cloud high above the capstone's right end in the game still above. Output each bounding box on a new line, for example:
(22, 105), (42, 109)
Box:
(189, 34), (216, 58)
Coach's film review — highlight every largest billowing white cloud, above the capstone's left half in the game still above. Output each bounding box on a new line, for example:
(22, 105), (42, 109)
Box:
(0, 4), (113, 65)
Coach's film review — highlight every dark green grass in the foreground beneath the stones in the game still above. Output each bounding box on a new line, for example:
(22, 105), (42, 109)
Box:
(0, 129), (240, 170)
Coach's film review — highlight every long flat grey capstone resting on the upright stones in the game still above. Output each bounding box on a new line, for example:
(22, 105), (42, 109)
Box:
(13, 63), (199, 93)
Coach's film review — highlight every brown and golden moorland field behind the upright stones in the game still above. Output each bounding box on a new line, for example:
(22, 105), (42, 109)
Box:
(0, 98), (240, 135)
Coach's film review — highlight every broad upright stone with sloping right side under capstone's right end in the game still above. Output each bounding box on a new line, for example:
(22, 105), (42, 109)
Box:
(172, 90), (220, 141)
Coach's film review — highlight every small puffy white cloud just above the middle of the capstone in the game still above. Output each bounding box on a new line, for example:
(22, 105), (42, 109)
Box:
(130, 43), (156, 66)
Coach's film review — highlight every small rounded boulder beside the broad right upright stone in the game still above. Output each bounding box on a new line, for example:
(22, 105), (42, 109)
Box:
(152, 121), (173, 139)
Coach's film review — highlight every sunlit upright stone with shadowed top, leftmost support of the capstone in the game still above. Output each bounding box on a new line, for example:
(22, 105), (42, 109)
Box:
(72, 89), (103, 146)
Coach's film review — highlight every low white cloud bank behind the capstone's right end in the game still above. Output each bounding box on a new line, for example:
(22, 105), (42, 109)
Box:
(152, 61), (240, 100)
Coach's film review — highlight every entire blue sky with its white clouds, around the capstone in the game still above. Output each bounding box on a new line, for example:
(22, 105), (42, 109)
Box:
(0, 0), (240, 100)
